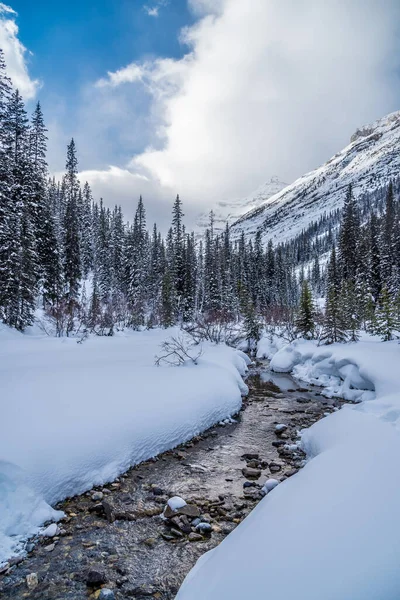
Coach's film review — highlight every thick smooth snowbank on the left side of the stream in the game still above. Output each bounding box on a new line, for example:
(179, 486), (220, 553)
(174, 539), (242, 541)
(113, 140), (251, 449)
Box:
(0, 326), (248, 564)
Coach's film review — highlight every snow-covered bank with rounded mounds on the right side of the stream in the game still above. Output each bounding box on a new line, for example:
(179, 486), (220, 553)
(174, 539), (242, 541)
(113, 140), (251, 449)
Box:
(177, 339), (400, 600)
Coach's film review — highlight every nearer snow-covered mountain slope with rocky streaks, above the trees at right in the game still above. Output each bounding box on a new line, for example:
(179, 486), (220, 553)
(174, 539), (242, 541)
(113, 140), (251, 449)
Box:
(232, 111), (400, 243)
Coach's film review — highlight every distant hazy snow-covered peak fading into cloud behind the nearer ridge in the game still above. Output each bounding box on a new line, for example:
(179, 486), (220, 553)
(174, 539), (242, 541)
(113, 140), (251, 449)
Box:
(196, 177), (287, 233)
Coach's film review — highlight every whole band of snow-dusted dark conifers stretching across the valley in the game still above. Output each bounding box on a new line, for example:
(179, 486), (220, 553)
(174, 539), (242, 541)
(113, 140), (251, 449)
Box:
(0, 51), (400, 343)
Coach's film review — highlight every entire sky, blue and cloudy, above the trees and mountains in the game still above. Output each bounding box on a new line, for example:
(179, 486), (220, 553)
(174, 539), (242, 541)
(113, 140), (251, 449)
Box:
(0, 0), (400, 224)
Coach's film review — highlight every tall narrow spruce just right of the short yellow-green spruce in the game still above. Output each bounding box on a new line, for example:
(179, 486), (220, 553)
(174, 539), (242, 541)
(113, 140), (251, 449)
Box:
(321, 247), (347, 344)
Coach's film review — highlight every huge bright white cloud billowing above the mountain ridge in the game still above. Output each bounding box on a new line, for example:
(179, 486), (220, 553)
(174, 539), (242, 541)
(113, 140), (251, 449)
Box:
(86, 0), (400, 225)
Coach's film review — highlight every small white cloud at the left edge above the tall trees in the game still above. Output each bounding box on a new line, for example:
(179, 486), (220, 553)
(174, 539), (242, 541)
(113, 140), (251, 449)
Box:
(0, 3), (40, 100)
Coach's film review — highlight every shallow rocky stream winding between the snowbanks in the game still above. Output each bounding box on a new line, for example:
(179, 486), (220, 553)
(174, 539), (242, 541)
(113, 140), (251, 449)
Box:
(0, 361), (341, 600)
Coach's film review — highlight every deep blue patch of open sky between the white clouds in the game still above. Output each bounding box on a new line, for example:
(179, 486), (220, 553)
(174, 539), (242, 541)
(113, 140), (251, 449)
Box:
(10, 0), (194, 101)
